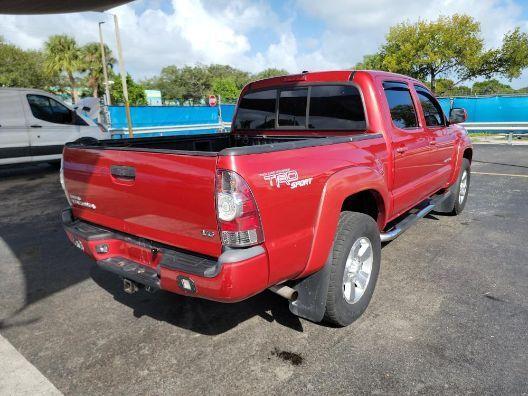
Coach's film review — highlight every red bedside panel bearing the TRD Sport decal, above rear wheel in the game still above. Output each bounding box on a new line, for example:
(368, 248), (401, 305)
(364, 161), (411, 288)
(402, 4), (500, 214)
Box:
(218, 137), (387, 284)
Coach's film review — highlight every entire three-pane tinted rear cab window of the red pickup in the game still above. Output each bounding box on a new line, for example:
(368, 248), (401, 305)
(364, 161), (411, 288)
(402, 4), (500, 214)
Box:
(233, 84), (367, 131)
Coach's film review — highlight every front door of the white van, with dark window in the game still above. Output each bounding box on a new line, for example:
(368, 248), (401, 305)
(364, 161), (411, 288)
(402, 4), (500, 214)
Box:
(24, 93), (87, 160)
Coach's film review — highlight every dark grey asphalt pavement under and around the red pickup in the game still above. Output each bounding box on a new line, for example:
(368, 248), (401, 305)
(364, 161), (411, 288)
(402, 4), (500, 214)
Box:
(0, 145), (528, 394)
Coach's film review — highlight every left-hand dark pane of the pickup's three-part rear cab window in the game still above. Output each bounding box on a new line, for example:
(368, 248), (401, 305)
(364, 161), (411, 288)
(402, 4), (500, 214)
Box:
(235, 89), (277, 129)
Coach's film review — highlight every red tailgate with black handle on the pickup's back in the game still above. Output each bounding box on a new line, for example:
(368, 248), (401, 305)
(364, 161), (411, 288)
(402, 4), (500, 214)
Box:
(63, 147), (221, 256)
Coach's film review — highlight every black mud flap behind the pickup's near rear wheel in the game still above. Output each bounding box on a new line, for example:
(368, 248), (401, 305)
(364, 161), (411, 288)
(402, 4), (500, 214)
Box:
(290, 254), (332, 322)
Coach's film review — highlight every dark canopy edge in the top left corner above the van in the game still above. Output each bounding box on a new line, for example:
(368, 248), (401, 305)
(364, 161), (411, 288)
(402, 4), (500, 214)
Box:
(0, 0), (131, 14)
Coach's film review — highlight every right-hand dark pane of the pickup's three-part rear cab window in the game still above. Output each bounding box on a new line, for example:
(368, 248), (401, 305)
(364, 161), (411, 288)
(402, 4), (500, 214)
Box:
(308, 85), (367, 130)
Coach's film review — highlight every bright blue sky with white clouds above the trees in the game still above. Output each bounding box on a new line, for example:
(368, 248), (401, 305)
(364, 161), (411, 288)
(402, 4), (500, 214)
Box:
(0, 0), (528, 88)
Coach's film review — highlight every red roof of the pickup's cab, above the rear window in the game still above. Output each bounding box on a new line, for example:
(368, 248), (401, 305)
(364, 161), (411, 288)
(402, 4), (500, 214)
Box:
(247, 70), (420, 88)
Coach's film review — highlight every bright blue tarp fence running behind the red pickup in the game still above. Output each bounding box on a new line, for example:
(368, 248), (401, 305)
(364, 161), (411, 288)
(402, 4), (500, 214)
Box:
(108, 96), (528, 137)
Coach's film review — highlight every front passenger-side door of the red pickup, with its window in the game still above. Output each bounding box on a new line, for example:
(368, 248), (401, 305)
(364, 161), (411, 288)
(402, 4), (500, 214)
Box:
(414, 85), (456, 189)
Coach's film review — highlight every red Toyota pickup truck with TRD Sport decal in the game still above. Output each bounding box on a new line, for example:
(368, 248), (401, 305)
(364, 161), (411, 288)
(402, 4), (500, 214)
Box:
(61, 71), (473, 326)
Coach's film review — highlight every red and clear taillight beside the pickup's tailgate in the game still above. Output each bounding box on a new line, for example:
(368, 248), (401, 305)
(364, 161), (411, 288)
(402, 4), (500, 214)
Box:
(216, 170), (264, 247)
